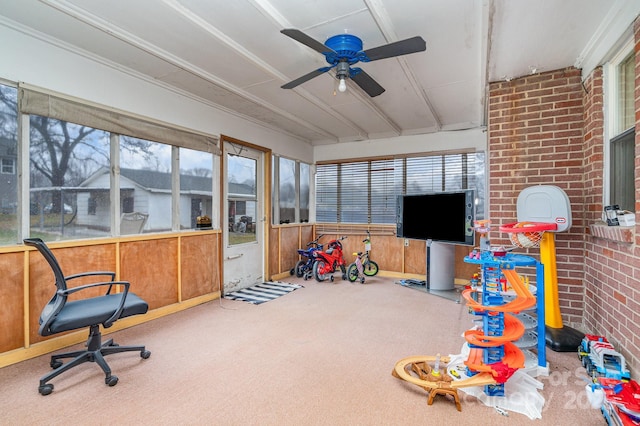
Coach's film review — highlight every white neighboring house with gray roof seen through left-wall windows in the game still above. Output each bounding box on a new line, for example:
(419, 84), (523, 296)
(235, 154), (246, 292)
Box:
(76, 167), (213, 232)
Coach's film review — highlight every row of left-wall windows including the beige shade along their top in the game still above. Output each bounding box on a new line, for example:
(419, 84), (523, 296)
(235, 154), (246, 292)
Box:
(0, 84), (220, 245)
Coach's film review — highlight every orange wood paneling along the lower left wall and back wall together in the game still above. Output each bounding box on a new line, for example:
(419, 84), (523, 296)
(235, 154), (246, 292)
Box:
(0, 223), (475, 367)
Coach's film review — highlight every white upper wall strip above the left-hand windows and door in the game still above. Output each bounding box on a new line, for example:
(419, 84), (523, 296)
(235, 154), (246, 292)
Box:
(0, 22), (313, 163)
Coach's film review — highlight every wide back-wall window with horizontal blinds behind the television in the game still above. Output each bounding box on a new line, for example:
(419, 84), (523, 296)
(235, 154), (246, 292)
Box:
(316, 153), (485, 224)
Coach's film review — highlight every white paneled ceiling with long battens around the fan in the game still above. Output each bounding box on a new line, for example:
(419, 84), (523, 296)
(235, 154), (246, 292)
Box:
(0, 0), (640, 145)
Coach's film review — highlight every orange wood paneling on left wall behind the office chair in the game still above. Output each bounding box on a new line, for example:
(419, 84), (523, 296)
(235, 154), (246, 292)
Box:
(0, 230), (222, 367)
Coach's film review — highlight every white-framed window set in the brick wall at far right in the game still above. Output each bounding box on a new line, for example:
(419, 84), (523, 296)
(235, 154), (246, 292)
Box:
(605, 41), (636, 211)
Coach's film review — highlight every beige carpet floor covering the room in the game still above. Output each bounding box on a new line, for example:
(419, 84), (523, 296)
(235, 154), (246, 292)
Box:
(0, 277), (606, 426)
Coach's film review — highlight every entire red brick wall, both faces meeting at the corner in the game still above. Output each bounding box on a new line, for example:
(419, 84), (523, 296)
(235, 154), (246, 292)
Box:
(488, 19), (640, 375)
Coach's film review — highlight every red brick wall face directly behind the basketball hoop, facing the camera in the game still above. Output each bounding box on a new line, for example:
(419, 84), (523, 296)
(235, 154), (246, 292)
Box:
(488, 68), (585, 328)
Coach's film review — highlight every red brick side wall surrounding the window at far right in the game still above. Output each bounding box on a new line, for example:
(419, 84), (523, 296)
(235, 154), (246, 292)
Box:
(584, 20), (640, 374)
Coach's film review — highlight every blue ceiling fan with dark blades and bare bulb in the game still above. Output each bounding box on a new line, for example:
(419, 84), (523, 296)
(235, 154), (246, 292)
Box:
(280, 29), (427, 97)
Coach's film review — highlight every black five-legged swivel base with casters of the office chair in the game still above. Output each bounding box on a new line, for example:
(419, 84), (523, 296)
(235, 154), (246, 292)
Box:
(38, 325), (151, 395)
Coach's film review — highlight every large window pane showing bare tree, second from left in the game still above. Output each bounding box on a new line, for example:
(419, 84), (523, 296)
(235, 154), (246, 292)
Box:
(29, 115), (111, 240)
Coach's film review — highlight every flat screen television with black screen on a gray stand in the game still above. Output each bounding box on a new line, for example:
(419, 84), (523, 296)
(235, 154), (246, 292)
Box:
(396, 189), (475, 246)
